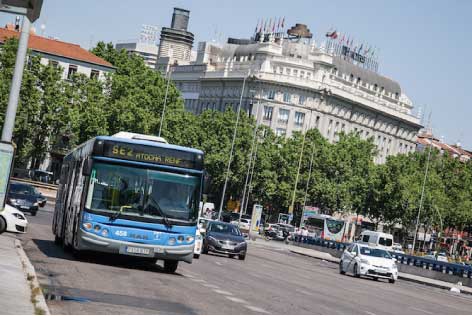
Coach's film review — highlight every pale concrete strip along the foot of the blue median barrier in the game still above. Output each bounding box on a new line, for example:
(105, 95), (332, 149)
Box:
(287, 245), (472, 294)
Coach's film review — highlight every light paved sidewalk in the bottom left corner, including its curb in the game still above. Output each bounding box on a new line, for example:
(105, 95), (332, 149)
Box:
(0, 233), (49, 315)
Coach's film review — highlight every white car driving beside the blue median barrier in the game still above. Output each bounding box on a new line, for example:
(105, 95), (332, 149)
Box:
(339, 243), (398, 283)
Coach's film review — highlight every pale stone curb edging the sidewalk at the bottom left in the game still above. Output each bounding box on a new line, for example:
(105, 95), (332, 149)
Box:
(15, 239), (51, 315)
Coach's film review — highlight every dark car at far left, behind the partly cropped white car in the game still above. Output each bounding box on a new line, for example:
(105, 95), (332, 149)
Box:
(7, 182), (39, 216)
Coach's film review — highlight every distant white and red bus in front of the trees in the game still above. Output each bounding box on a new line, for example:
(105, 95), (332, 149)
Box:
(302, 214), (346, 242)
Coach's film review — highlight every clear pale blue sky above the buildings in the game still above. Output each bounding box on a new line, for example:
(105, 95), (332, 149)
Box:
(0, 0), (472, 150)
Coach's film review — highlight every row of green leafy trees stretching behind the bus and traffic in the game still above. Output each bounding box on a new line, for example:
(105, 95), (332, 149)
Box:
(0, 40), (472, 232)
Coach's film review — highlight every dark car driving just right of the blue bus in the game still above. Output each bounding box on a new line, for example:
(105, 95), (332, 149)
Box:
(202, 222), (247, 260)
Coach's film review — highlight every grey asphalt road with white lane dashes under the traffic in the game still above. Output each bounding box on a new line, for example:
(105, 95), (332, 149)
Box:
(21, 204), (472, 314)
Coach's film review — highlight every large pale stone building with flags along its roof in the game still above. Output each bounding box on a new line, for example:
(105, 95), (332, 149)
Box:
(172, 24), (421, 163)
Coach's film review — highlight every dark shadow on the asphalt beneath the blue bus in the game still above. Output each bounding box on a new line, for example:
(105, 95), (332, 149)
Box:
(32, 239), (182, 276)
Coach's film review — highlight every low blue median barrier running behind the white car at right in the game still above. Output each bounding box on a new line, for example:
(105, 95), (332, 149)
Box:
(292, 236), (472, 287)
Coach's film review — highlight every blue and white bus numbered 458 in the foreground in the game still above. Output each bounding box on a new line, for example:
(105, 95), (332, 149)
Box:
(52, 132), (204, 273)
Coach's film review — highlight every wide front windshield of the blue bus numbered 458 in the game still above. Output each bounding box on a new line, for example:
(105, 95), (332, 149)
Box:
(86, 163), (200, 221)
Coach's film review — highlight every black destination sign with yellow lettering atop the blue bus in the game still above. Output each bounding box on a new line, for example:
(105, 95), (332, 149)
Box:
(103, 141), (203, 169)
